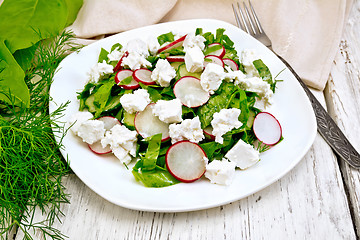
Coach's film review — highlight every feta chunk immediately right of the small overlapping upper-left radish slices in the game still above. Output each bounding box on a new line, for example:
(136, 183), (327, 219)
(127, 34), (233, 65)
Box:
(151, 59), (176, 87)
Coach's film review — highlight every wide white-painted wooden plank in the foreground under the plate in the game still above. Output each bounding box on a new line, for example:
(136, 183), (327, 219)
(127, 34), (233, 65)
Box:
(16, 93), (356, 240)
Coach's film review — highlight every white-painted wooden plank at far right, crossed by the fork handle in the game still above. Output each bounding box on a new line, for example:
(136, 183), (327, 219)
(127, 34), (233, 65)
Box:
(324, 0), (360, 236)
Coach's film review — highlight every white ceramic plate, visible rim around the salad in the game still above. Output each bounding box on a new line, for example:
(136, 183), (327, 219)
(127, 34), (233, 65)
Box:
(50, 19), (316, 212)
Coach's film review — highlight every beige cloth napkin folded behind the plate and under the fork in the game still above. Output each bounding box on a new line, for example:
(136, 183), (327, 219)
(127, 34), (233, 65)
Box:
(71, 0), (353, 90)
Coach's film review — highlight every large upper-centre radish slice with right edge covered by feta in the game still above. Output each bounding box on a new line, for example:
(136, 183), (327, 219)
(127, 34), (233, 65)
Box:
(174, 76), (210, 108)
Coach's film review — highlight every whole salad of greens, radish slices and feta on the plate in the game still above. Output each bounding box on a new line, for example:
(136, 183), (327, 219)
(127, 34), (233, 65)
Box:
(69, 28), (282, 187)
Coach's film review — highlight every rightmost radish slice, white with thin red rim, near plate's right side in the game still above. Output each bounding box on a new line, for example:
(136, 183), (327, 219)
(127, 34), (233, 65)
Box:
(253, 112), (282, 146)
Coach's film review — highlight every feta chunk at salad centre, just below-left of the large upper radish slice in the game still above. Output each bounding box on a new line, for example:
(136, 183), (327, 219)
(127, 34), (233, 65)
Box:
(152, 98), (182, 123)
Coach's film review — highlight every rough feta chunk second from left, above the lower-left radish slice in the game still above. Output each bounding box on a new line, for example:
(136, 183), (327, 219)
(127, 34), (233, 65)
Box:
(77, 119), (106, 144)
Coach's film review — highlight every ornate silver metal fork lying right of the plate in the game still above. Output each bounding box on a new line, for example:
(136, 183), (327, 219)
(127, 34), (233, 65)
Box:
(232, 0), (360, 169)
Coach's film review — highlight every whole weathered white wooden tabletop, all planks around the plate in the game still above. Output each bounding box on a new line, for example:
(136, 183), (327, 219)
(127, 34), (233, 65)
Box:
(12, 1), (360, 240)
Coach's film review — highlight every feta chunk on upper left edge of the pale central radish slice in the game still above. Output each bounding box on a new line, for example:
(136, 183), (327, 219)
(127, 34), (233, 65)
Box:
(120, 89), (151, 113)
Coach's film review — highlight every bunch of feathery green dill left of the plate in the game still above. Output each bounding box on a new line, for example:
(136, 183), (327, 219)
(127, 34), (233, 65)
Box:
(0, 32), (81, 239)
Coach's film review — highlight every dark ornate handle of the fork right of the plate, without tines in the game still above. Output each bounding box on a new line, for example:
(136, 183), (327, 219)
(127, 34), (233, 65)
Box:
(275, 53), (360, 169)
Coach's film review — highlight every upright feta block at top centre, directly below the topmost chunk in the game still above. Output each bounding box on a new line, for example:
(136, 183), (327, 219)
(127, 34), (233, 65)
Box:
(185, 46), (205, 72)
